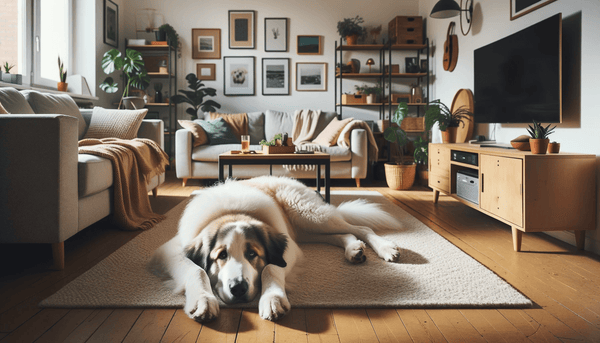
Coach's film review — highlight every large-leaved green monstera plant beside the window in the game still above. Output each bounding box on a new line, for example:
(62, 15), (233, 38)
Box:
(100, 49), (150, 108)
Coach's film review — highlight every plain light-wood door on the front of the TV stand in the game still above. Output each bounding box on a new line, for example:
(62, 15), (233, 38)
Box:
(479, 154), (523, 226)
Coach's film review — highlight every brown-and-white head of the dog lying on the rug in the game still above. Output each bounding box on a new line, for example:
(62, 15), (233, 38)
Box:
(185, 215), (287, 304)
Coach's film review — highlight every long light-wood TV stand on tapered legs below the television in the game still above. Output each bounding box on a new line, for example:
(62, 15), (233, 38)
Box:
(429, 143), (596, 251)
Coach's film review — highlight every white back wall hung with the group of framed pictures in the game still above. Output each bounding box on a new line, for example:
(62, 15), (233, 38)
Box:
(124, 0), (419, 119)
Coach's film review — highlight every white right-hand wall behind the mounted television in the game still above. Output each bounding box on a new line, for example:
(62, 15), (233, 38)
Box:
(419, 0), (600, 253)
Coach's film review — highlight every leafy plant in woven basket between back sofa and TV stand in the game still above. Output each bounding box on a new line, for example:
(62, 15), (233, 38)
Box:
(383, 102), (417, 190)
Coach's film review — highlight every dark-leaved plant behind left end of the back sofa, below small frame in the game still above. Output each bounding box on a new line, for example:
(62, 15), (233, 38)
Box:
(171, 73), (221, 120)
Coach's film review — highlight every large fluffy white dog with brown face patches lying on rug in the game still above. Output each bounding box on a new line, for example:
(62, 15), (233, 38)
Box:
(149, 176), (400, 322)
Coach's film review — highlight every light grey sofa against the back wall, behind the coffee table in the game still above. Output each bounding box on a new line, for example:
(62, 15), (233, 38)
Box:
(175, 110), (368, 187)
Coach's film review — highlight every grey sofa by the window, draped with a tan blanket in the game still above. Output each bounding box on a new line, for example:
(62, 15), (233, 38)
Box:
(0, 87), (165, 269)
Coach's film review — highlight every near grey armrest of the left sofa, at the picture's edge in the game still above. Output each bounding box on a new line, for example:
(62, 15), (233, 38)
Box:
(0, 114), (78, 243)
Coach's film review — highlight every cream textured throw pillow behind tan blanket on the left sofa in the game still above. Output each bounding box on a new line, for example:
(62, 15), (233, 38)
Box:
(84, 107), (148, 139)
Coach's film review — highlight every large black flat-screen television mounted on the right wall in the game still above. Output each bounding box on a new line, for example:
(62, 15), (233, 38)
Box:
(473, 13), (562, 123)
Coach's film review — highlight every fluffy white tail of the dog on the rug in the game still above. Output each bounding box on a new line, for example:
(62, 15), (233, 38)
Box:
(337, 199), (400, 229)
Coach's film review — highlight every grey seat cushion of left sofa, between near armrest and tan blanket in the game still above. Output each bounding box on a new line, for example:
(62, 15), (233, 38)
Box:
(77, 154), (113, 198)
